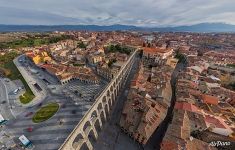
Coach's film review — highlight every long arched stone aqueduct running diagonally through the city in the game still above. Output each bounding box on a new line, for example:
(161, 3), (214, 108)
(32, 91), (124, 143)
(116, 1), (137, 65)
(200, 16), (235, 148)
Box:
(59, 50), (138, 150)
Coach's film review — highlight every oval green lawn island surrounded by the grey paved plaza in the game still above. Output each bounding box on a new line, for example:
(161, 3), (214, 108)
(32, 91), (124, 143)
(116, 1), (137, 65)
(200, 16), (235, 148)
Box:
(32, 103), (59, 123)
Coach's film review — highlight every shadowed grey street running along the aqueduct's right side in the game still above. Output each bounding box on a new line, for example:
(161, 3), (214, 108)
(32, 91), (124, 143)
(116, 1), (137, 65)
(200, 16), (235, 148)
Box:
(93, 53), (141, 150)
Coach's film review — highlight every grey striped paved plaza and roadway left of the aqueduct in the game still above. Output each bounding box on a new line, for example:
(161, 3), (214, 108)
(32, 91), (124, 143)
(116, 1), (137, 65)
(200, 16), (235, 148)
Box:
(0, 56), (107, 150)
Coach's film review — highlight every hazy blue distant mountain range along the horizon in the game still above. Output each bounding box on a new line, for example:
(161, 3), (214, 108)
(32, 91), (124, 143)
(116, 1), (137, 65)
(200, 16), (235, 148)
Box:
(0, 23), (235, 32)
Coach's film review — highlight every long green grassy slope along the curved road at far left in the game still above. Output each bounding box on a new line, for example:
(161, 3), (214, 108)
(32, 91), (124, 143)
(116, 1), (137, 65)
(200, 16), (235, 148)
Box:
(0, 53), (35, 104)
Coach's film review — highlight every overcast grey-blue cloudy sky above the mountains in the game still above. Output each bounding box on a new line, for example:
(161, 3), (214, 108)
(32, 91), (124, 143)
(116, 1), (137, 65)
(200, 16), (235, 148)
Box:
(0, 0), (235, 27)
